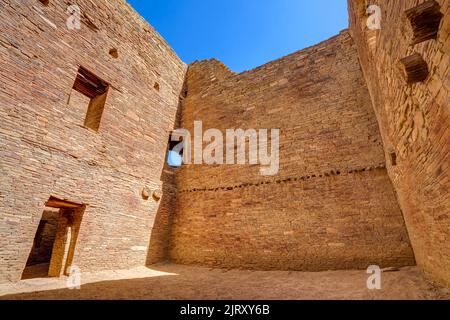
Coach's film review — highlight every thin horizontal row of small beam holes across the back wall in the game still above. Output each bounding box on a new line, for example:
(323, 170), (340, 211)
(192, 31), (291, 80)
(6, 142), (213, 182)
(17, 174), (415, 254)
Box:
(180, 164), (386, 193)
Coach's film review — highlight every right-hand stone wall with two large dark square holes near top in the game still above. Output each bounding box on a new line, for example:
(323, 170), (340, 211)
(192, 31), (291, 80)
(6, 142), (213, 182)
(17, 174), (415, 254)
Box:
(349, 0), (450, 284)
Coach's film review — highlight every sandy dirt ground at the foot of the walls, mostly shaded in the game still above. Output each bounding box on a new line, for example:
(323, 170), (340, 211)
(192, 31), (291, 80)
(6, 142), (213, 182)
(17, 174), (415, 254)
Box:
(0, 264), (450, 300)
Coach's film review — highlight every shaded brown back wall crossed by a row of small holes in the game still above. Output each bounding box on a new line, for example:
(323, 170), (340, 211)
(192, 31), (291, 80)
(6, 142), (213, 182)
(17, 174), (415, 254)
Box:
(171, 31), (414, 271)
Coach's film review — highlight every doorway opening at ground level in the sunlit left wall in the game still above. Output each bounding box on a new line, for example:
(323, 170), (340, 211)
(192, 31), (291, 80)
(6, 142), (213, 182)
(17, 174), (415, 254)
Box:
(22, 197), (86, 280)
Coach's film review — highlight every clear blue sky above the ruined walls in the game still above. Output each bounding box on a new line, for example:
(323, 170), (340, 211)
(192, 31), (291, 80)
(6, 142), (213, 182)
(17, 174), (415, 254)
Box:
(127, 0), (348, 72)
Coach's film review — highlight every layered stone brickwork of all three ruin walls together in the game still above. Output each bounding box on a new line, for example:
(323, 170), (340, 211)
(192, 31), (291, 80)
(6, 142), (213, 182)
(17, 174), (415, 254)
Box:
(0, 0), (450, 285)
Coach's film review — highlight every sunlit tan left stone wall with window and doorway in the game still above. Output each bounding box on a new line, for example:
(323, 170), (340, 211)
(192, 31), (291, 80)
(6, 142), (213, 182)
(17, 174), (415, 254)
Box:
(0, 0), (186, 282)
